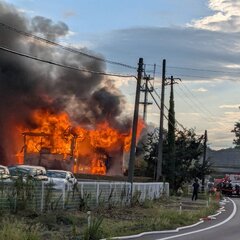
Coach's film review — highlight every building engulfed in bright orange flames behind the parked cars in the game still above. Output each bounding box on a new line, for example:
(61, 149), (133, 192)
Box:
(19, 111), (142, 174)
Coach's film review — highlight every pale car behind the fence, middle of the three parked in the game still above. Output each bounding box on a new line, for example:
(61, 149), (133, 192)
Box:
(8, 165), (48, 181)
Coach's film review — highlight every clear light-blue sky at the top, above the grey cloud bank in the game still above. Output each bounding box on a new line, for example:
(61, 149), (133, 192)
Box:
(7, 0), (208, 33)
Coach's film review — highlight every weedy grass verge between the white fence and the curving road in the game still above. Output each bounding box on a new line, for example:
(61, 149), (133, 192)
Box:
(0, 191), (218, 240)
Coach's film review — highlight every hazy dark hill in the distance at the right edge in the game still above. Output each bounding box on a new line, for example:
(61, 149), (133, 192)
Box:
(207, 148), (240, 174)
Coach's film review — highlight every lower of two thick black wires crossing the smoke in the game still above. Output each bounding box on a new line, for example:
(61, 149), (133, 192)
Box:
(0, 46), (136, 78)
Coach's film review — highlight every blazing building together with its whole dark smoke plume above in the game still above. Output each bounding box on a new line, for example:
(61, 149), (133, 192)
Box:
(0, 3), (143, 174)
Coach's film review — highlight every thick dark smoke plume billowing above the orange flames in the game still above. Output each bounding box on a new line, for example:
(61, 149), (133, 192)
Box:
(0, 2), (129, 164)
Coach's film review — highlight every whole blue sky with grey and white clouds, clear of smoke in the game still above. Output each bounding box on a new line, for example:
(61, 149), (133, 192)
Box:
(2, 0), (240, 149)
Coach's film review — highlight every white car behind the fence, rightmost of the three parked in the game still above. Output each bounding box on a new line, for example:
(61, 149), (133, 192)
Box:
(47, 170), (77, 189)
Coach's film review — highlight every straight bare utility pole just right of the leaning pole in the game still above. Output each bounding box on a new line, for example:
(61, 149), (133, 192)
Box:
(156, 59), (166, 181)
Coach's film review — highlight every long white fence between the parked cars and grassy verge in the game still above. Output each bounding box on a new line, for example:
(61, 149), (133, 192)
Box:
(0, 182), (169, 212)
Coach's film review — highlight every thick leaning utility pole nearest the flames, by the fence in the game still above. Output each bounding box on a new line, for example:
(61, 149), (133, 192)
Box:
(128, 58), (143, 191)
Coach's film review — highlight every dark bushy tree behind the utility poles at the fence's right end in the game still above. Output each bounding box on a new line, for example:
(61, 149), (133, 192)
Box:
(144, 129), (209, 191)
